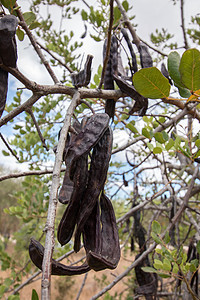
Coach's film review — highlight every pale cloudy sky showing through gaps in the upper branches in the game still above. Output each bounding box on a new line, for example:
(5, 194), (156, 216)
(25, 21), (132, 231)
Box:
(0, 0), (200, 169)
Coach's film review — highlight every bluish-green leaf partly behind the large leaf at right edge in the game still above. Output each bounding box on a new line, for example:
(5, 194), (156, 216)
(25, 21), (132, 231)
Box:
(168, 51), (191, 98)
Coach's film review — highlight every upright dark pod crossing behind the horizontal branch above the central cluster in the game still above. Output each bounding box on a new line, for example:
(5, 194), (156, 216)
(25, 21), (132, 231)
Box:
(103, 35), (118, 118)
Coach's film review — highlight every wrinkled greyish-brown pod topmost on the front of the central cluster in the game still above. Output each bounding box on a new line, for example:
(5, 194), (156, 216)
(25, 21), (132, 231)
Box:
(66, 113), (109, 180)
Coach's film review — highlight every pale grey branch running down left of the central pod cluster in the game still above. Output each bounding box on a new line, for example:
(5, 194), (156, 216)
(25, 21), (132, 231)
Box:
(41, 91), (80, 300)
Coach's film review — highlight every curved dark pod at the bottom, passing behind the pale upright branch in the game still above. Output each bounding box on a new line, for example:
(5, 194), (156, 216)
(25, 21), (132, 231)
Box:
(29, 239), (90, 276)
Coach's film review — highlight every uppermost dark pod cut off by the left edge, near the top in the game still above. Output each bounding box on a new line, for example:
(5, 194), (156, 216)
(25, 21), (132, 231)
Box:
(0, 15), (18, 68)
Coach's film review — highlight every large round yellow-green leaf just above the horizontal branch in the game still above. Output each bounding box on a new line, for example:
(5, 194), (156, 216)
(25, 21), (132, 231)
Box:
(133, 67), (170, 99)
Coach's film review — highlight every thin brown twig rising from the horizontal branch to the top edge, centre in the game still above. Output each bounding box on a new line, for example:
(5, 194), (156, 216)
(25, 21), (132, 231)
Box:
(98, 0), (114, 89)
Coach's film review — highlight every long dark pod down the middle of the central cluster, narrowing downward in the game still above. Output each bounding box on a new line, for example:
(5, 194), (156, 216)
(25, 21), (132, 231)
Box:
(74, 127), (113, 252)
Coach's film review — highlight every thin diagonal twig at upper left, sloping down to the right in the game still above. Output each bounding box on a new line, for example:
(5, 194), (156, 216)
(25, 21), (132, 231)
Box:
(16, 3), (59, 84)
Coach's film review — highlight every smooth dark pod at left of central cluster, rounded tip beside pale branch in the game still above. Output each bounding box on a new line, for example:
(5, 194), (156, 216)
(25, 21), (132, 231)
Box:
(57, 155), (88, 245)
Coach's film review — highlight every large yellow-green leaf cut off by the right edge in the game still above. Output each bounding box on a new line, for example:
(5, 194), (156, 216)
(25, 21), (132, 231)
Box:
(179, 49), (200, 91)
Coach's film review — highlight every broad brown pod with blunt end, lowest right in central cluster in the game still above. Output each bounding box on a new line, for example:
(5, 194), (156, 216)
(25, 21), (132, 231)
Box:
(84, 192), (120, 271)
